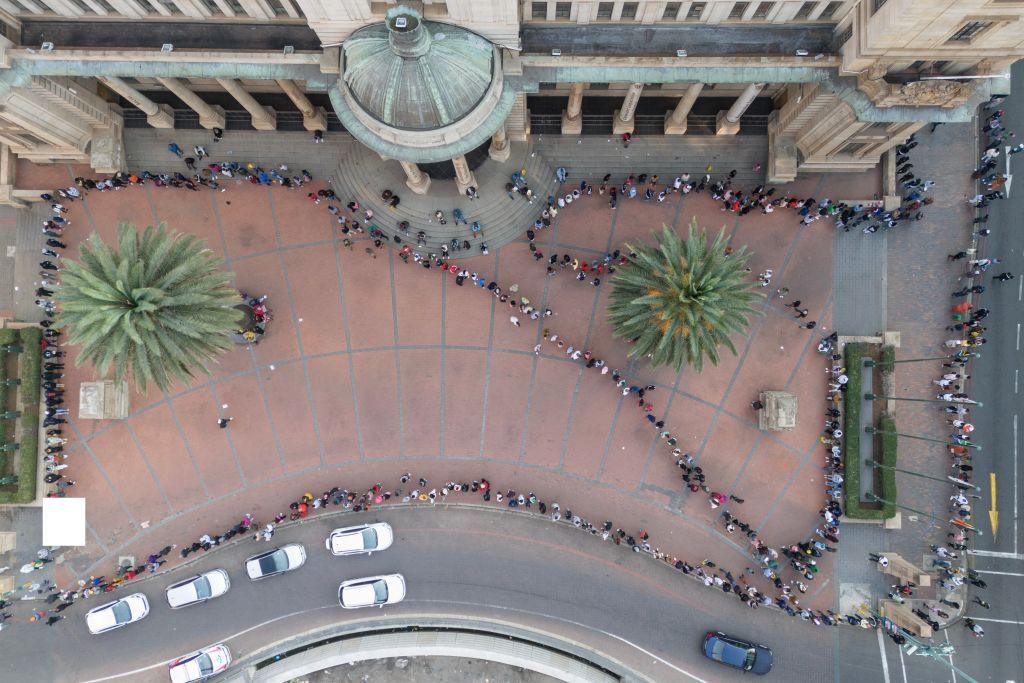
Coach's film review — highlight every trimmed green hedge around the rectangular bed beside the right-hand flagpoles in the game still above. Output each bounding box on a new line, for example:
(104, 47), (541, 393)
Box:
(843, 342), (896, 519)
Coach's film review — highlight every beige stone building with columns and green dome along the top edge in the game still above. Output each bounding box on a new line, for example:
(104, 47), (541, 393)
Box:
(0, 0), (1024, 203)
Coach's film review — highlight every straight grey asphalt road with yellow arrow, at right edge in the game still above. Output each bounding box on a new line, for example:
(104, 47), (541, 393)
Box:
(868, 62), (1024, 683)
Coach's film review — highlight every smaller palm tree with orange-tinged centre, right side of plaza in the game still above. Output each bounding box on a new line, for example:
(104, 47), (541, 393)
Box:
(608, 217), (763, 372)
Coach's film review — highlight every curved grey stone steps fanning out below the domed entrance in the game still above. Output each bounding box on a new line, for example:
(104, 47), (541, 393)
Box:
(331, 142), (557, 254)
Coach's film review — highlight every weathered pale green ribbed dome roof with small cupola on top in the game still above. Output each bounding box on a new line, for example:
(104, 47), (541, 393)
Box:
(343, 5), (495, 130)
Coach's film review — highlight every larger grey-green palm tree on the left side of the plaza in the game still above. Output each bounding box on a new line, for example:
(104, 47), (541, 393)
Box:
(56, 223), (241, 391)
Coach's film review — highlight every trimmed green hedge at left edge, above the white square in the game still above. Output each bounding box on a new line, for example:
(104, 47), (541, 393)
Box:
(0, 328), (43, 505)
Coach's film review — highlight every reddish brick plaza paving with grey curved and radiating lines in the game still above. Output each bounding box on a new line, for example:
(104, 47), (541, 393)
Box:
(9, 139), (877, 618)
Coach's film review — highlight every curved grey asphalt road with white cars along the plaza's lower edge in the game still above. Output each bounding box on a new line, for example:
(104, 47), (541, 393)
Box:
(2, 506), (843, 681)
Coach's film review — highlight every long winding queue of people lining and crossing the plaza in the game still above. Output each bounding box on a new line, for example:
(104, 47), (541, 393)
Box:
(8, 107), (999, 647)
